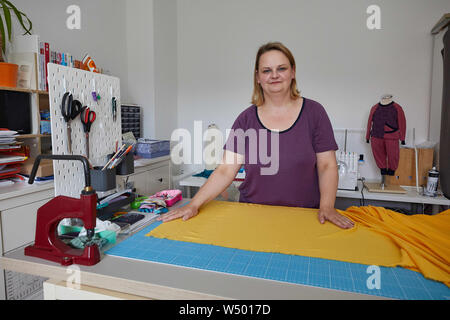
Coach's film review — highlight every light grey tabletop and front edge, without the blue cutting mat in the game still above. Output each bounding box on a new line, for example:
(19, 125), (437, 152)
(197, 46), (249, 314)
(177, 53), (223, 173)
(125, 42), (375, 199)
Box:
(0, 199), (380, 299)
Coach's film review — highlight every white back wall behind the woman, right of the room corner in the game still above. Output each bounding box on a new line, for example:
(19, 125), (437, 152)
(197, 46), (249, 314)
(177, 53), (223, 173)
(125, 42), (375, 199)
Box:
(178, 0), (450, 178)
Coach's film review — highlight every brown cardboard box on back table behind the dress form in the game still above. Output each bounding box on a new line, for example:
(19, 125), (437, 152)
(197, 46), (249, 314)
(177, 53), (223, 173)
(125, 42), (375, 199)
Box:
(386, 148), (434, 186)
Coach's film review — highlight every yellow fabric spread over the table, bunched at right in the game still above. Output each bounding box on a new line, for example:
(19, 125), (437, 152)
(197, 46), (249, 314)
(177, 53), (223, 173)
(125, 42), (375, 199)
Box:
(147, 201), (450, 286)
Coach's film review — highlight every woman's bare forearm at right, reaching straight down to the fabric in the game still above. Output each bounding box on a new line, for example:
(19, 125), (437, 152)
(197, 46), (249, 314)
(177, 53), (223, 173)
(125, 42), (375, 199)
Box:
(317, 163), (339, 209)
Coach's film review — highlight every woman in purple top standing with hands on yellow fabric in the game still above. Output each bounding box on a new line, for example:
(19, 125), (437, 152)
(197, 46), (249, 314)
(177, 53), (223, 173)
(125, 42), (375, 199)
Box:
(160, 42), (353, 229)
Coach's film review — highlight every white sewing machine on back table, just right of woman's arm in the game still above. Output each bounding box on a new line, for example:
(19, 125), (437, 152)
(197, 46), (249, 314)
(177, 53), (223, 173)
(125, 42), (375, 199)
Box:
(336, 151), (358, 191)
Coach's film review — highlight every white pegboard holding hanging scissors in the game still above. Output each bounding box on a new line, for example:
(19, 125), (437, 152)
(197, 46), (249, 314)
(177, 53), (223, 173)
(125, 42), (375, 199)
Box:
(48, 63), (122, 198)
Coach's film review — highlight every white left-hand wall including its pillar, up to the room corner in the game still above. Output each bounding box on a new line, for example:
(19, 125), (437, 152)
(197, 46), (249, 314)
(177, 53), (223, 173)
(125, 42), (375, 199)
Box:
(6, 0), (177, 139)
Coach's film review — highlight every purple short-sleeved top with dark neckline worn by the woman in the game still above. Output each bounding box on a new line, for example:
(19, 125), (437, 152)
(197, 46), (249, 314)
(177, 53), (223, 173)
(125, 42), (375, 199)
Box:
(224, 98), (338, 208)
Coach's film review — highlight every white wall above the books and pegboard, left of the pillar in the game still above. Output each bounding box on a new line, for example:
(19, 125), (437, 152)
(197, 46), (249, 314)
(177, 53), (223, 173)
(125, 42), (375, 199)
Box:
(8, 0), (128, 100)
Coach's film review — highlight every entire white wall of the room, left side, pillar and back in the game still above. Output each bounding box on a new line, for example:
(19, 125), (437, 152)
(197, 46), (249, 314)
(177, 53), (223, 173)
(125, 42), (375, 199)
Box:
(5, 0), (450, 178)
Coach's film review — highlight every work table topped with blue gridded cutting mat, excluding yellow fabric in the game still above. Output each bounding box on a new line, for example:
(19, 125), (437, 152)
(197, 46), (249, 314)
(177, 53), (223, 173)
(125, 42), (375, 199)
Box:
(0, 192), (448, 300)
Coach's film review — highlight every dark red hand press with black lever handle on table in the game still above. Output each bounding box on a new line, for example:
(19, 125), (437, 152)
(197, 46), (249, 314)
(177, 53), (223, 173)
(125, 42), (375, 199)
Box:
(25, 155), (100, 266)
